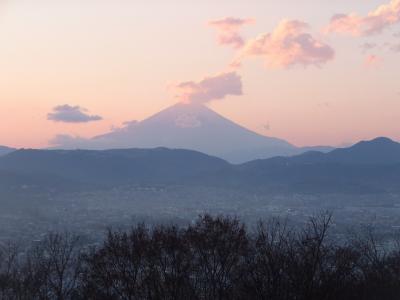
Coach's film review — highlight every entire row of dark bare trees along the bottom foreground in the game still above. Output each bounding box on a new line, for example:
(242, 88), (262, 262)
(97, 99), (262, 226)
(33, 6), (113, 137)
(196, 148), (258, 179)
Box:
(0, 215), (400, 300)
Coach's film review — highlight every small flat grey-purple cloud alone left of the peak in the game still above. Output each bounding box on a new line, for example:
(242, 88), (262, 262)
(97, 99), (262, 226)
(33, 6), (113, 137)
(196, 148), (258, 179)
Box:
(47, 104), (103, 123)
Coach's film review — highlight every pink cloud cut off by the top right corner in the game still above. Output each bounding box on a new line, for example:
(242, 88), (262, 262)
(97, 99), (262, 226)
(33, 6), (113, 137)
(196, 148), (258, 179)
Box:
(326, 0), (400, 36)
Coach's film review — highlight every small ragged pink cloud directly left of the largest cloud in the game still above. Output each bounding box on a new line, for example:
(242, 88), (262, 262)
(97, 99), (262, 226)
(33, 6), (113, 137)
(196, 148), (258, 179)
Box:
(208, 17), (254, 49)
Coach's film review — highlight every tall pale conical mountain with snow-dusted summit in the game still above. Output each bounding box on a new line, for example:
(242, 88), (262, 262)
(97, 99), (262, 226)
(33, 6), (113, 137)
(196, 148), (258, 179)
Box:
(51, 103), (333, 163)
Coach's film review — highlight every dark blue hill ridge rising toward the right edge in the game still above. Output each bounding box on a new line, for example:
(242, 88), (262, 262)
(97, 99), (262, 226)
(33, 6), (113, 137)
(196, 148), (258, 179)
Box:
(222, 138), (400, 193)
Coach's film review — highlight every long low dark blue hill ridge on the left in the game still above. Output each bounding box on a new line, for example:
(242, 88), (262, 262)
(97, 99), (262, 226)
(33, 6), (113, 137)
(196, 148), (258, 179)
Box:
(0, 148), (228, 186)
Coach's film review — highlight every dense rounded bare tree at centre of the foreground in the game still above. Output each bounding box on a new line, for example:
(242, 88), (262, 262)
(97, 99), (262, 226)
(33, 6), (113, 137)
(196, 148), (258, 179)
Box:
(185, 215), (249, 299)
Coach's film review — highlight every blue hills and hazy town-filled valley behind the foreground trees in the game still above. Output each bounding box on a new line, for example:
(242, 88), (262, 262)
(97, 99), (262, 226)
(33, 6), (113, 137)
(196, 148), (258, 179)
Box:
(0, 138), (400, 244)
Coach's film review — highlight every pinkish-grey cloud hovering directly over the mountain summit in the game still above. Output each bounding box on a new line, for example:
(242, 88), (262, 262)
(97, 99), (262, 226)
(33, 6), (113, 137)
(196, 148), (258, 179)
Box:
(172, 72), (243, 104)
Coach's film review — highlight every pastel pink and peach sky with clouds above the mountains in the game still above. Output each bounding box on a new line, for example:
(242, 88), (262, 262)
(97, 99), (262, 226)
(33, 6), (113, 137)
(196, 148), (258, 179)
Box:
(0, 0), (400, 147)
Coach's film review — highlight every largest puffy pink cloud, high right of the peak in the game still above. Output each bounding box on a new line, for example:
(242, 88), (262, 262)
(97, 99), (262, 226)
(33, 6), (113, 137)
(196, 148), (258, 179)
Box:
(236, 20), (335, 68)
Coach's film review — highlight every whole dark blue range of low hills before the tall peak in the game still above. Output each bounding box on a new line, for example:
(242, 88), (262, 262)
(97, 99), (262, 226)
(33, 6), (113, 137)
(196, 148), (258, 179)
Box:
(0, 138), (400, 194)
